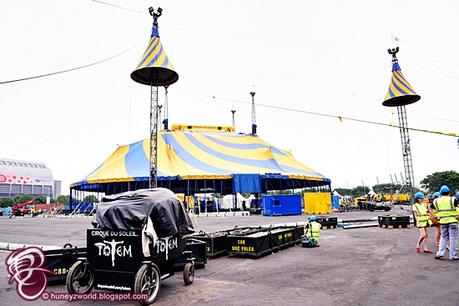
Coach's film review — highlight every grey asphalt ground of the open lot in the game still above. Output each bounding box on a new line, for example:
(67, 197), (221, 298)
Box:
(0, 208), (459, 306)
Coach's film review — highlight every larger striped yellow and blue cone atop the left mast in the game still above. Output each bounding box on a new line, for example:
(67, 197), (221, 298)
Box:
(131, 7), (178, 86)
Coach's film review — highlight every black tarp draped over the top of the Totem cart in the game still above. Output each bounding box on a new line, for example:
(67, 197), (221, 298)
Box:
(96, 188), (194, 238)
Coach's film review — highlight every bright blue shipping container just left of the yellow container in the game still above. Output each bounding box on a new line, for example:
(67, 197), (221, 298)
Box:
(262, 194), (302, 216)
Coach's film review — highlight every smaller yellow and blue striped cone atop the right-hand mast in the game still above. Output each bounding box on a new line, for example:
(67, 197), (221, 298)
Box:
(383, 47), (421, 106)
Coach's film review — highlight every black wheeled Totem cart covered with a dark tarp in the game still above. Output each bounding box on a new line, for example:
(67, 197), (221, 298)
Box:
(66, 188), (195, 305)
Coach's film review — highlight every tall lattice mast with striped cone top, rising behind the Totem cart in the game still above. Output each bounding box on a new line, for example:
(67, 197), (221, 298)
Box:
(131, 7), (178, 188)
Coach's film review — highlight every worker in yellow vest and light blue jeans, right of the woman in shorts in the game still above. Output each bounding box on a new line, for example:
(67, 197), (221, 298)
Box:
(431, 185), (459, 260)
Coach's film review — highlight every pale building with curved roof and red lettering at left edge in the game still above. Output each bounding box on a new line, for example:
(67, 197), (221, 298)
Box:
(0, 158), (61, 198)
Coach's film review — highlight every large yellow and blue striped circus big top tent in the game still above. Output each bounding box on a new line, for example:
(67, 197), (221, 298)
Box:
(71, 130), (330, 194)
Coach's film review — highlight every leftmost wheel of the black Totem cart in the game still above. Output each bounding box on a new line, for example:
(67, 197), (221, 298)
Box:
(65, 260), (94, 293)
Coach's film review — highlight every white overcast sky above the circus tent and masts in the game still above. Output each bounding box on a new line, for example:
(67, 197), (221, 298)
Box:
(0, 0), (459, 193)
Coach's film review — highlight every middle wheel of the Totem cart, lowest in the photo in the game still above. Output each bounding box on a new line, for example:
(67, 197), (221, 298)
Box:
(134, 263), (161, 305)
